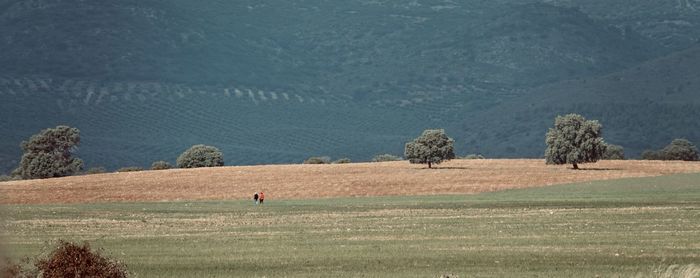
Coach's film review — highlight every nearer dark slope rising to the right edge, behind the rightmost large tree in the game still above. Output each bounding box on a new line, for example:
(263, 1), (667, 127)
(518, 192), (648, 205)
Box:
(463, 47), (700, 157)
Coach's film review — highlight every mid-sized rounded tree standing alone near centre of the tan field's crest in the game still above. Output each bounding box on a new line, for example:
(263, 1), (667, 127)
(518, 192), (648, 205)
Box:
(404, 129), (455, 168)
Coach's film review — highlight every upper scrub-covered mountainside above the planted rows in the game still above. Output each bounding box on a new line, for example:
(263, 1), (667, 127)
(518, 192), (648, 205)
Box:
(0, 0), (658, 90)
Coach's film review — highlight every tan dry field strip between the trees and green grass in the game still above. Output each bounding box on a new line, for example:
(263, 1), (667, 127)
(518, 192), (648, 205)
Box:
(0, 159), (700, 204)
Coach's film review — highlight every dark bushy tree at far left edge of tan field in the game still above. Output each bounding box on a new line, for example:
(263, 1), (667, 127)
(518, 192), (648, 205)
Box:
(13, 126), (83, 179)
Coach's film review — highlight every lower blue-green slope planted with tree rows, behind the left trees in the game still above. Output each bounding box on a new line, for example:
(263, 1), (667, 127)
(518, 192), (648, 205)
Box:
(0, 76), (474, 169)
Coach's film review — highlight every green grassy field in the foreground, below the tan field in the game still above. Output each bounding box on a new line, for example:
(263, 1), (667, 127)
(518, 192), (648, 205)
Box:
(2, 174), (700, 277)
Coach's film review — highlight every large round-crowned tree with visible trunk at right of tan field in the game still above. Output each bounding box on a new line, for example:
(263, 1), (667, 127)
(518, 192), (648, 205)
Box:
(544, 114), (605, 169)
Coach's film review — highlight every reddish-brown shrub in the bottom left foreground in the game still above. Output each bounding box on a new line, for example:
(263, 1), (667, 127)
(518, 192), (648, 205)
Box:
(34, 240), (128, 278)
